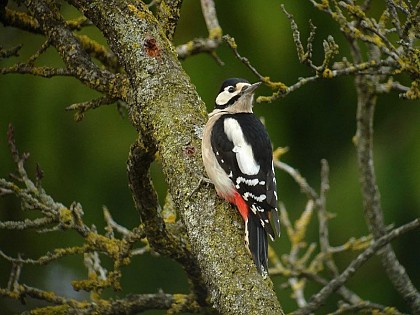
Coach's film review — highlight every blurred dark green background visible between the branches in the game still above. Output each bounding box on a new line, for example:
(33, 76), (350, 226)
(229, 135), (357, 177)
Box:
(0, 0), (420, 314)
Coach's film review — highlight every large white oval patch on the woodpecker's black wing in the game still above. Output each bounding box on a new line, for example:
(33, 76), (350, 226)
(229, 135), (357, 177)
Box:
(223, 118), (260, 175)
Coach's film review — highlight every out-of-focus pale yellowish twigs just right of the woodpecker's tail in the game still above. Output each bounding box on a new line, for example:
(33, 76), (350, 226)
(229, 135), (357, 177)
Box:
(270, 156), (400, 307)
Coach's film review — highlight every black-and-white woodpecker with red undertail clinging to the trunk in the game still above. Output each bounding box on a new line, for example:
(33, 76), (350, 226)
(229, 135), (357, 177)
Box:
(202, 78), (280, 278)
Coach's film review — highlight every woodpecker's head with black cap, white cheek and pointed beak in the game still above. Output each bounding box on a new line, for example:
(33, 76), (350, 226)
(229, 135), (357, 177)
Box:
(215, 78), (261, 113)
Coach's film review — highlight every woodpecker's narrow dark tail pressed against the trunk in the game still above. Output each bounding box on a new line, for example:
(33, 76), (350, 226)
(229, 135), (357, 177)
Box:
(245, 214), (268, 278)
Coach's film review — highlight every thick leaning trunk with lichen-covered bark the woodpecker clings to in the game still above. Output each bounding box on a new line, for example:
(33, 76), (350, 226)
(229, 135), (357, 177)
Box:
(72, 0), (282, 314)
